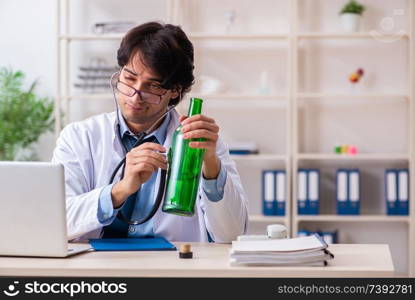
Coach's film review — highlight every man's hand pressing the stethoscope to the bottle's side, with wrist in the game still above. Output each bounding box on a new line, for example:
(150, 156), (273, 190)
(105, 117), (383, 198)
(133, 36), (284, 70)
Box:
(111, 143), (167, 208)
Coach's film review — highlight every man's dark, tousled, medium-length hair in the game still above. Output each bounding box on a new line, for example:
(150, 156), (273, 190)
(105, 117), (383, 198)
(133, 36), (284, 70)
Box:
(117, 22), (194, 105)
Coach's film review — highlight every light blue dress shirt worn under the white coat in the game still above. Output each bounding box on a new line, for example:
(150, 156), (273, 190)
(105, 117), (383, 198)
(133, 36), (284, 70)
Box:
(97, 113), (226, 237)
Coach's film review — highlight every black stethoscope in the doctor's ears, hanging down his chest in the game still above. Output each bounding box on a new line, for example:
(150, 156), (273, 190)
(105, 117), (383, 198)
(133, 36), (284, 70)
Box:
(109, 71), (177, 225)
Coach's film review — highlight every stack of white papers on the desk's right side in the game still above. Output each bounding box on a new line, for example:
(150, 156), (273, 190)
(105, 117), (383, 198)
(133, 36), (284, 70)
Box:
(230, 234), (334, 266)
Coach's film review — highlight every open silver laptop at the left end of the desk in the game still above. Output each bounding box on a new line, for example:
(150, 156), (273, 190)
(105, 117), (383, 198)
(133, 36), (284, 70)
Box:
(0, 161), (91, 257)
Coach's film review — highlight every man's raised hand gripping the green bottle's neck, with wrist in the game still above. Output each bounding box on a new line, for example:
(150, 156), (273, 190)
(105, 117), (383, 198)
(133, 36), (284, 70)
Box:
(179, 115), (220, 179)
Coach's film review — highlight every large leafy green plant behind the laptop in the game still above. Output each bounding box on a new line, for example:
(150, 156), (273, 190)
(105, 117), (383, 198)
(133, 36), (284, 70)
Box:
(0, 68), (54, 160)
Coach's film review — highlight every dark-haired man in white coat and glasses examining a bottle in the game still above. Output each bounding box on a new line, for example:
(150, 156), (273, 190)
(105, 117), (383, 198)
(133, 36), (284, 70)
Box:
(52, 22), (248, 243)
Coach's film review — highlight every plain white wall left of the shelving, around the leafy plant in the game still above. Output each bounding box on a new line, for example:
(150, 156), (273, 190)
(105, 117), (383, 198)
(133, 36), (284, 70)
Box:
(0, 0), (56, 160)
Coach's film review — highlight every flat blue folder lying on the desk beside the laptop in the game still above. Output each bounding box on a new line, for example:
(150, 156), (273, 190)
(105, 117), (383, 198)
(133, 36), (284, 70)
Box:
(89, 237), (176, 251)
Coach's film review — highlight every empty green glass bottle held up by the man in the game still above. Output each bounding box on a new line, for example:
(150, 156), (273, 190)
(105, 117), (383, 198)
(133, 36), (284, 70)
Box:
(162, 98), (205, 216)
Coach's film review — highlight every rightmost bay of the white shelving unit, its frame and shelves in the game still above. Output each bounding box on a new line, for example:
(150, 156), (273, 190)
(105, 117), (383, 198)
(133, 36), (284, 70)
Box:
(291, 0), (415, 276)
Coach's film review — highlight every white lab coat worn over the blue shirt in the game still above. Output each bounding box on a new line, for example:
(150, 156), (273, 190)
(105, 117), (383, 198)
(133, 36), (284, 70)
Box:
(52, 110), (248, 243)
